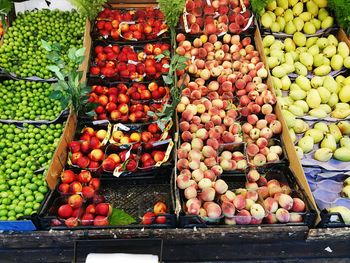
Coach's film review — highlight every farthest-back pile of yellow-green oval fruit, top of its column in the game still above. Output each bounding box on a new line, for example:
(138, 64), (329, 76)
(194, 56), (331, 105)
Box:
(260, 0), (334, 35)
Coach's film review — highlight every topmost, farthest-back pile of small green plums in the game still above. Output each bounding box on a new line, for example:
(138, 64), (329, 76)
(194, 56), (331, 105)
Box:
(0, 9), (85, 79)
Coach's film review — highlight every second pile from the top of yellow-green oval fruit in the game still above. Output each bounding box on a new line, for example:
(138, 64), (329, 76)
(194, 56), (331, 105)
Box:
(263, 32), (350, 79)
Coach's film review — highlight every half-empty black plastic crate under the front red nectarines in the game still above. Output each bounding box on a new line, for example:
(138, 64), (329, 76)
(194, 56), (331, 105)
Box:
(39, 173), (176, 230)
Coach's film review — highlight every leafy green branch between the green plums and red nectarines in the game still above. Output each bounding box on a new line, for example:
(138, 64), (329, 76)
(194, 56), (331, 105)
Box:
(41, 40), (95, 116)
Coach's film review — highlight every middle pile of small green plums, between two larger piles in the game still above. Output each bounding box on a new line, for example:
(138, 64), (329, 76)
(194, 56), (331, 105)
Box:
(0, 80), (62, 121)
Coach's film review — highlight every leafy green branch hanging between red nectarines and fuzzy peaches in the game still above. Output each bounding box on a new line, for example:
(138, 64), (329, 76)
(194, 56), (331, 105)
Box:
(147, 50), (188, 131)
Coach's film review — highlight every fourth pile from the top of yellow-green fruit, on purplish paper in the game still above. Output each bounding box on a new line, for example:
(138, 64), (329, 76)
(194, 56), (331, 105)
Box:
(290, 119), (350, 162)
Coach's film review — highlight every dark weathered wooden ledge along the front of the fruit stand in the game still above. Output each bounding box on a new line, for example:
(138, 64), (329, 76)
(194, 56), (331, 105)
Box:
(0, 227), (350, 262)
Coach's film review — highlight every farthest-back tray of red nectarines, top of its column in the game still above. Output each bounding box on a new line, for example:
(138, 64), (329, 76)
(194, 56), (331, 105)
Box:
(95, 8), (168, 41)
